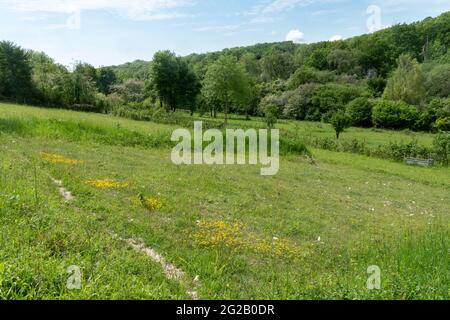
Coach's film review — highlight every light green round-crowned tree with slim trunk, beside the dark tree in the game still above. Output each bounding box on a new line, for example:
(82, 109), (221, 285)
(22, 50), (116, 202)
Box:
(203, 56), (251, 126)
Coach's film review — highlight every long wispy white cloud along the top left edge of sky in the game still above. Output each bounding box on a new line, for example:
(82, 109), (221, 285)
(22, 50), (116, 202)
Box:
(0, 0), (191, 20)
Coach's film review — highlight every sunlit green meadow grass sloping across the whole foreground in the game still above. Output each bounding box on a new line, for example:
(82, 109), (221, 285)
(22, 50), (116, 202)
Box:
(0, 105), (450, 299)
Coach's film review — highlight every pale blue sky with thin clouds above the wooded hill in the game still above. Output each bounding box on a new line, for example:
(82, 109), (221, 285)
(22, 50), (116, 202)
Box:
(0, 0), (450, 66)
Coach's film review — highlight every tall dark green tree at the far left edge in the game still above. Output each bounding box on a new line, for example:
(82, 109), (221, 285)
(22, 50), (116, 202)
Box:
(0, 41), (32, 101)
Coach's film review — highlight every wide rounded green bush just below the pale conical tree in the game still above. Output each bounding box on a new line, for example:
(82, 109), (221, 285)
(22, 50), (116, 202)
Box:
(372, 100), (420, 130)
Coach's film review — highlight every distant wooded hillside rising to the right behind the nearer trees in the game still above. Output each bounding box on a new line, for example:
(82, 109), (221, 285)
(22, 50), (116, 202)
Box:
(106, 12), (450, 80)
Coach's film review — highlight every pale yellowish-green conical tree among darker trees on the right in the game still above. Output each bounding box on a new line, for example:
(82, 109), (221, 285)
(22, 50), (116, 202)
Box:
(383, 54), (426, 105)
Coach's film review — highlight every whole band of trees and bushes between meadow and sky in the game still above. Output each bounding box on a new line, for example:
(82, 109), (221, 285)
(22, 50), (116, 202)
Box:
(0, 13), (450, 132)
